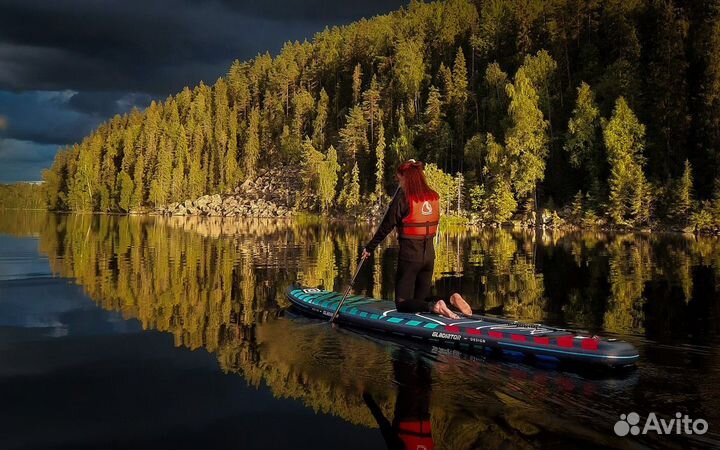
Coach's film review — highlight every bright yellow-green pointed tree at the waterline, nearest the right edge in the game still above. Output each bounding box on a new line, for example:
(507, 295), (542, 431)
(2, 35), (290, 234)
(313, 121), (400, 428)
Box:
(603, 97), (651, 226)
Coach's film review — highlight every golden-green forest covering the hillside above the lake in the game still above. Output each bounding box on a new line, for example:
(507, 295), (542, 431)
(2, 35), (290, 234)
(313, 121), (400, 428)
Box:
(25, 0), (720, 229)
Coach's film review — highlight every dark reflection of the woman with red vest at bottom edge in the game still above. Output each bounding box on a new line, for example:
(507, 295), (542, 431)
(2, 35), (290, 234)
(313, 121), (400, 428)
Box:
(363, 349), (434, 450)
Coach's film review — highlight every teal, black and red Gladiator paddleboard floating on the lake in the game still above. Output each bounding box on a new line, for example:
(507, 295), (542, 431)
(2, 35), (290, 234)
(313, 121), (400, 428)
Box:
(287, 287), (639, 367)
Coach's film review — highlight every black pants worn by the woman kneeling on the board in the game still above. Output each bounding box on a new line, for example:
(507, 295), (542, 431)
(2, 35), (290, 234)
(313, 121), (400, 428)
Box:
(395, 239), (437, 313)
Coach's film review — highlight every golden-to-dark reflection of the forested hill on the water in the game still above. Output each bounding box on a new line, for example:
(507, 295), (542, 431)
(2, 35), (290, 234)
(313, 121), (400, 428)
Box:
(0, 213), (720, 449)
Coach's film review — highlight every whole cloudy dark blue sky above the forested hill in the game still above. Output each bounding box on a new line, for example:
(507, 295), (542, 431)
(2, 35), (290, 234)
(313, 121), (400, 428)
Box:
(0, 0), (407, 183)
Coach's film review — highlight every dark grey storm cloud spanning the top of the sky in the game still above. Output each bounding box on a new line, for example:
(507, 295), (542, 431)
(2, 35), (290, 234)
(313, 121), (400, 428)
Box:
(0, 0), (403, 96)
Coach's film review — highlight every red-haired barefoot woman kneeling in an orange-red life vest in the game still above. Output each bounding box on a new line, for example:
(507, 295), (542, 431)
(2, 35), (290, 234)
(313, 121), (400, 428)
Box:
(362, 159), (472, 319)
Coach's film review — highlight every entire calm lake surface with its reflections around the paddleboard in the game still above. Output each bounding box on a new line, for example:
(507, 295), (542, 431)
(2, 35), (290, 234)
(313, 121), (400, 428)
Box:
(0, 211), (720, 449)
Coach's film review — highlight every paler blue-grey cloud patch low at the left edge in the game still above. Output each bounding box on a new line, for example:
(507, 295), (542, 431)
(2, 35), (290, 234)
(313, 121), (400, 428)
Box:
(0, 139), (58, 183)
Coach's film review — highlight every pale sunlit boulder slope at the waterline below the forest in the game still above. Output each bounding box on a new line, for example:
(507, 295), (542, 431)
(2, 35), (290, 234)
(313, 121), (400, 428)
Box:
(154, 167), (302, 217)
